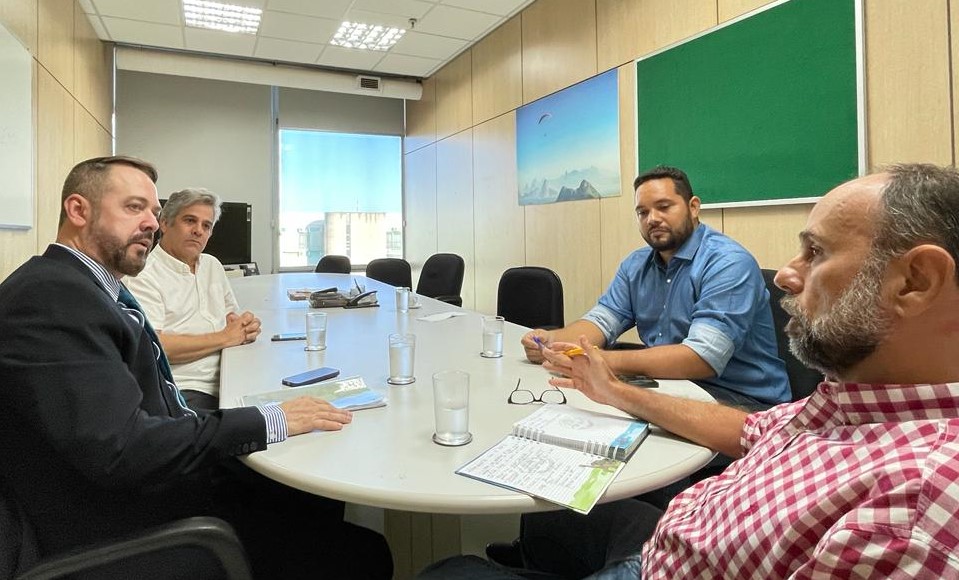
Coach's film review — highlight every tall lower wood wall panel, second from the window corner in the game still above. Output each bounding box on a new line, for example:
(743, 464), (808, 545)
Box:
(436, 129), (476, 309)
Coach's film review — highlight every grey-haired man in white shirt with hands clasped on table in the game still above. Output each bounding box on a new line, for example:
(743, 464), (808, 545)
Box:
(126, 189), (260, 409)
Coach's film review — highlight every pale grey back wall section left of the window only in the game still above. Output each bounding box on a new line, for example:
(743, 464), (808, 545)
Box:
(116, 71), (273, 272)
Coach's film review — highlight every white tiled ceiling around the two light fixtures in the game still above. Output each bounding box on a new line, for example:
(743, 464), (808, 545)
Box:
(80, 0), (533, 77)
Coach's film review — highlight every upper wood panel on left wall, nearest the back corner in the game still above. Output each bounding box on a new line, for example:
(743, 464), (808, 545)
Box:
(73, 10), (113, 131)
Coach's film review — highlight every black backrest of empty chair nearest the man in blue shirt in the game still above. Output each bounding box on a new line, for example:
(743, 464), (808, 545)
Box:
(496, 266), (564, 329)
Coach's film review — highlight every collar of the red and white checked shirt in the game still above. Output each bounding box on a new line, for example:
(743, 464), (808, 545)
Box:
(809, 381), (959, 425)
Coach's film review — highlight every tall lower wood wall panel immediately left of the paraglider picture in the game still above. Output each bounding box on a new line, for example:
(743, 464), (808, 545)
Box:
(473, 113), (526, 314)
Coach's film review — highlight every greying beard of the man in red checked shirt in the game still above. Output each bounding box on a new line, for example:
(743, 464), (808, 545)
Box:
(782, 256), (891, 379)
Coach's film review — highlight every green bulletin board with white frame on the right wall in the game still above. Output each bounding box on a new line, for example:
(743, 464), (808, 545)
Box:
(636, 0), (865, 207)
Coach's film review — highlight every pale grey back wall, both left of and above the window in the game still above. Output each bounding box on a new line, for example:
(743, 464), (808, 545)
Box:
(116, 70), (404, 273)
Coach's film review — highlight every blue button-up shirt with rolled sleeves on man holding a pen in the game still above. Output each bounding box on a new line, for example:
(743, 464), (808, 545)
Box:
(583, 224), (790, 404)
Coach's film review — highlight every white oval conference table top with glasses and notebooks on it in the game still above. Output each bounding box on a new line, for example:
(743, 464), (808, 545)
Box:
(220, 273), (713, 514)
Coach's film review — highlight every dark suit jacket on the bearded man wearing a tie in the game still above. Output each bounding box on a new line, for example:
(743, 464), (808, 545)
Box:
(0, 246), (266, 555)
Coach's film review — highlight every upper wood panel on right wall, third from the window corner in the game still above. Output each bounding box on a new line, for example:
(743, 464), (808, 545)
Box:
(472, 16), (523, 125)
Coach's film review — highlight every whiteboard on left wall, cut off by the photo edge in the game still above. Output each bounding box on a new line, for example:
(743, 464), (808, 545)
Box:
(0, 25), (34, 229)
